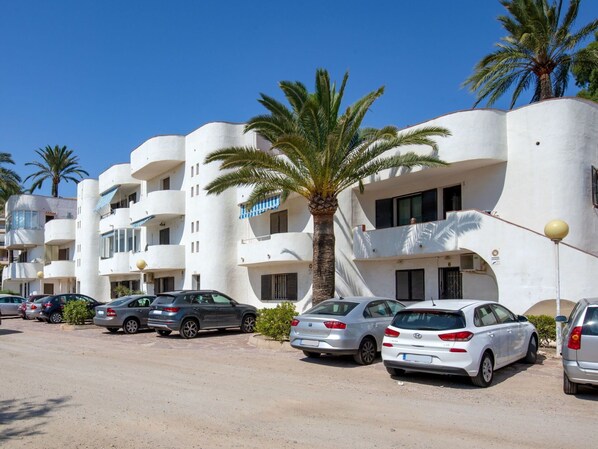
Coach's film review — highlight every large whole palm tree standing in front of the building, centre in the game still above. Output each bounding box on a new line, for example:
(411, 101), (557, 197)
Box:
(205, 69), (449, 304)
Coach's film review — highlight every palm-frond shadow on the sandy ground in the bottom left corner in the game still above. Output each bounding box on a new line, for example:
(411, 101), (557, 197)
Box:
(0, 397), (70, 440)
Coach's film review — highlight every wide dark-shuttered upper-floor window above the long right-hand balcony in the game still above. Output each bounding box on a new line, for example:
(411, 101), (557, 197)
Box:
(376, 189), (438, 229)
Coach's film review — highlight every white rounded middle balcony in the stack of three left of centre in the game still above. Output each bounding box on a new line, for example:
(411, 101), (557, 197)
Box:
(131, 190), (185, 224)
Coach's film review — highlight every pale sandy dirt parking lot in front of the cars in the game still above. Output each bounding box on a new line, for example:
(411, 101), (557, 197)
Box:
(0, 318), (598, 449)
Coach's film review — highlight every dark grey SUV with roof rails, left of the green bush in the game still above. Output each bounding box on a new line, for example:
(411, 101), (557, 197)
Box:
(147, 290), (257, 338)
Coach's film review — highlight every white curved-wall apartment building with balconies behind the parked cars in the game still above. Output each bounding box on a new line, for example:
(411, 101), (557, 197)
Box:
(3, 98), (598, 314)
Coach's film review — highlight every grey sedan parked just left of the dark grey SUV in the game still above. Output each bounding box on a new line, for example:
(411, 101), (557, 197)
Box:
(93, 295), (156, 334)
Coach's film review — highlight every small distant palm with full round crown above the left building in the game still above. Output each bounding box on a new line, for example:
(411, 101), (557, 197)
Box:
(25, 145), (89, 197)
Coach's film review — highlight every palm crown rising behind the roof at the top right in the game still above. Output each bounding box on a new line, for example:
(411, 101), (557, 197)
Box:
(463, 0), (598, 108)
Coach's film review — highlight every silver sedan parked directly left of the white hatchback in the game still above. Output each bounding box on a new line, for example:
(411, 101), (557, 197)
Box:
(290, 297), (405, 365)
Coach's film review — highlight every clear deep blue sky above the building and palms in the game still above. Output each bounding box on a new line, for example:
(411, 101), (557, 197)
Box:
(0, 0), (598, 196)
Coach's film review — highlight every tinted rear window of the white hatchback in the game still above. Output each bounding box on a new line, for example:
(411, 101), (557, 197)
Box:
(392, 309), (465, 331)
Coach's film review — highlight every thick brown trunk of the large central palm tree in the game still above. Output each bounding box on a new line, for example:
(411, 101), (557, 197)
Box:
(312, 212), (336, 305)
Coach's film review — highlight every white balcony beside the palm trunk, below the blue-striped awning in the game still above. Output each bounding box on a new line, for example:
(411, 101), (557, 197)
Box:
(237, 232), (313, 266)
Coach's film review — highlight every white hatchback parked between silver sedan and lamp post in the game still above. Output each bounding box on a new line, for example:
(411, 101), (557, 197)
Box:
(382, 300), (538, 387)
